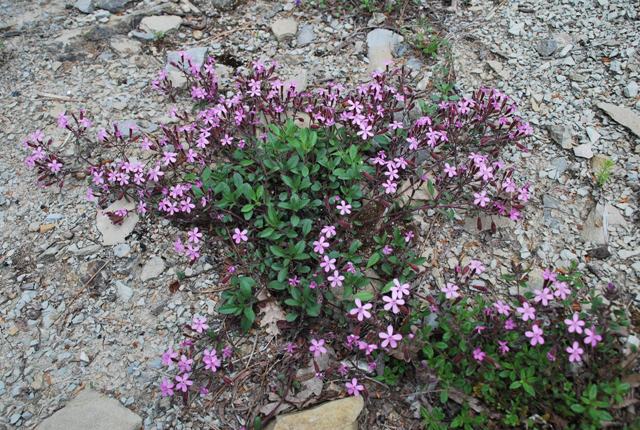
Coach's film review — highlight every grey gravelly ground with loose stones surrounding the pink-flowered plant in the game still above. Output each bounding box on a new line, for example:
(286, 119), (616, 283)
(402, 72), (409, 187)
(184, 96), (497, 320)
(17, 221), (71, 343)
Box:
(0, 0), (640, 429)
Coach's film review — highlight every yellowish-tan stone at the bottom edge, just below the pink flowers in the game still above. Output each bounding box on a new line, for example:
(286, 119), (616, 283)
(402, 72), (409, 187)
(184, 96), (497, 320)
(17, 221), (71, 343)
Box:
(266, 396), (364, 430)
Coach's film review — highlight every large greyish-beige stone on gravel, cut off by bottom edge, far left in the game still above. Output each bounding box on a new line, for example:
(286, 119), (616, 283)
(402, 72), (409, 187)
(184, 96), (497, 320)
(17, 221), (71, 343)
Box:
(36, 389), (142, 430)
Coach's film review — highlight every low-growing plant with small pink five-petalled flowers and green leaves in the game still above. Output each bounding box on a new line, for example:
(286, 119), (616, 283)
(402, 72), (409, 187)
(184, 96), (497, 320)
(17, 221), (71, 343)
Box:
(24, 53), (628, 428)
